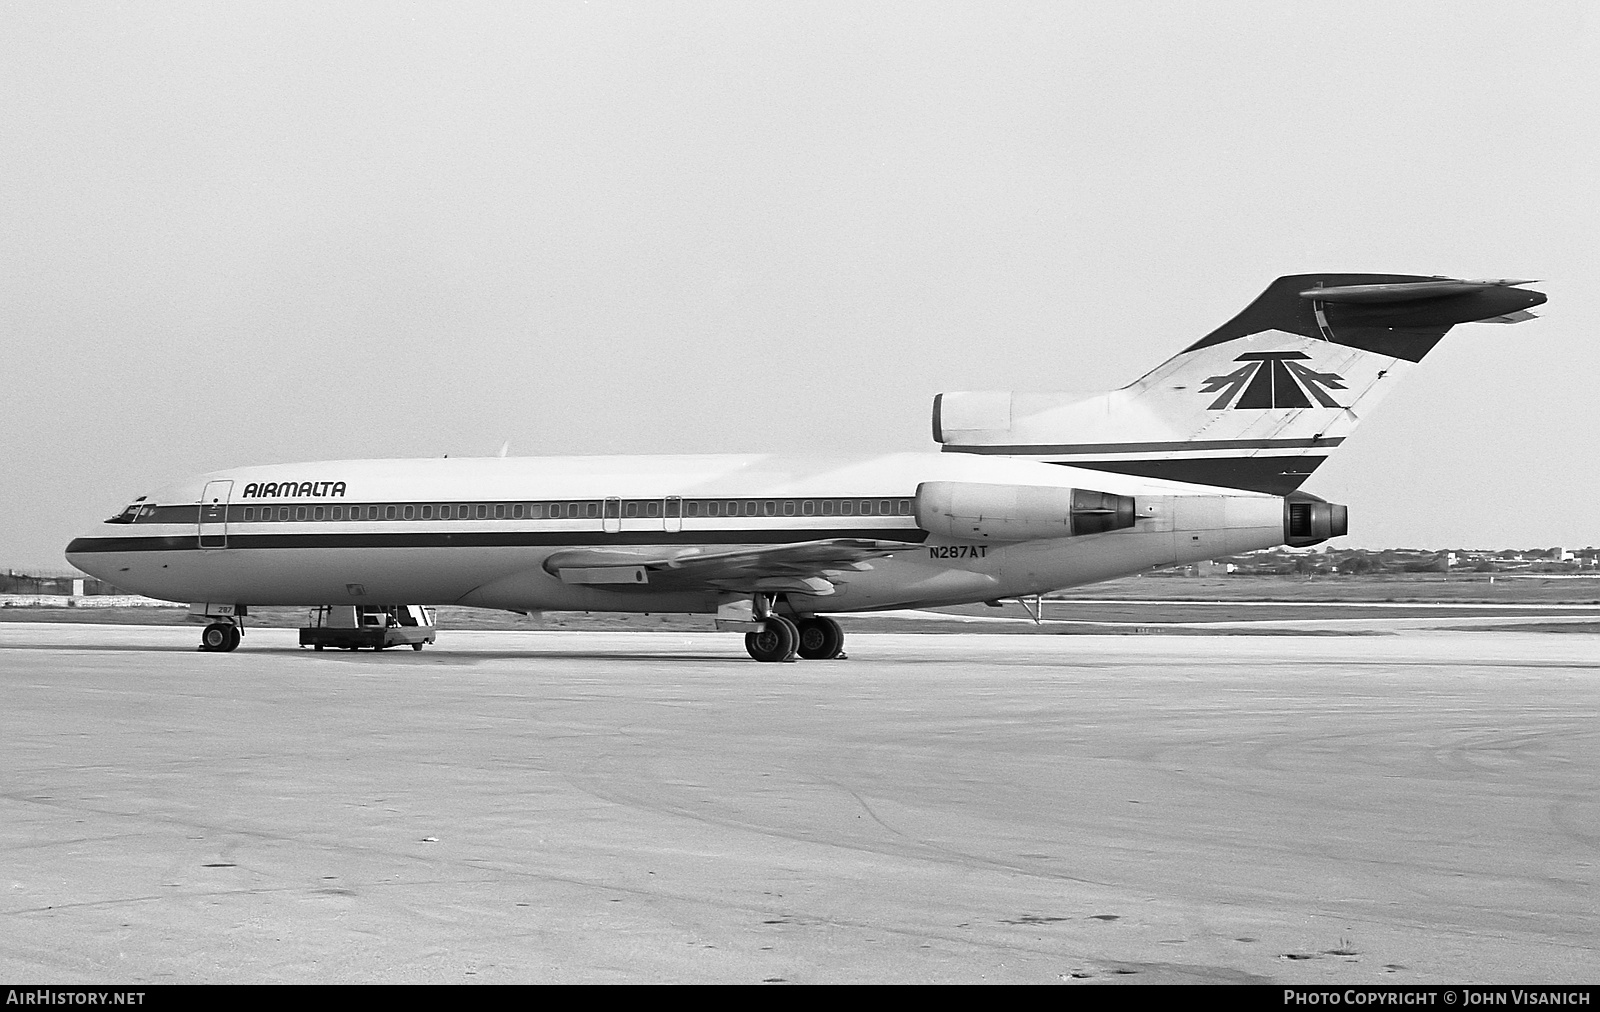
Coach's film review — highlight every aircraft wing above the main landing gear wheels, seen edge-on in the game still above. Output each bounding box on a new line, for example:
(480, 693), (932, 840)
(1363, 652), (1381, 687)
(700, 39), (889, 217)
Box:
(544, 538), (915, 596)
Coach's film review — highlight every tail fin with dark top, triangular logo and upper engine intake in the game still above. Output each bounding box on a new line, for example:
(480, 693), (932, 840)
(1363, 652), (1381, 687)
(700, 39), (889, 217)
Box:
(933, 274), (1544, 495)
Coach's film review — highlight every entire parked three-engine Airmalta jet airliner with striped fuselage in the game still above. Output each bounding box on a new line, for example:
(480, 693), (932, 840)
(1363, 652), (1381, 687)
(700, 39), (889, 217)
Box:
(67, 274), (1546, 661)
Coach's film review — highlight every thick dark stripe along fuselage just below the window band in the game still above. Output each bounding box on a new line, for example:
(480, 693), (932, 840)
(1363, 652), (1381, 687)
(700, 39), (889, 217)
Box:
(67, 527), (928, 556)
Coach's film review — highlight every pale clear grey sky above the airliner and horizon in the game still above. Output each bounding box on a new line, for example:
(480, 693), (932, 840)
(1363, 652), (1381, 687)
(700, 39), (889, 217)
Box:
(0, 0), (1600, 572)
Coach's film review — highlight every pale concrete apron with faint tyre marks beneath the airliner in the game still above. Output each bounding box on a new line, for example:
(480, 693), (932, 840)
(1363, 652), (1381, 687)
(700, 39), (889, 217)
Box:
(0, 620), (1600, 985)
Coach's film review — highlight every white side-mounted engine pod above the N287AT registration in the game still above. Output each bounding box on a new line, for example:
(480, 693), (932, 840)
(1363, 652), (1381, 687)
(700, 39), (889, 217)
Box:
(917, 482), (1134, 541)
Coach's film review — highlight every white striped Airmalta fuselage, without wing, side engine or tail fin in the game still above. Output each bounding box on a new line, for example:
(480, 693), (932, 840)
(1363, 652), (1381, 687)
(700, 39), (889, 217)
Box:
(67, 453), (1283, 613)
